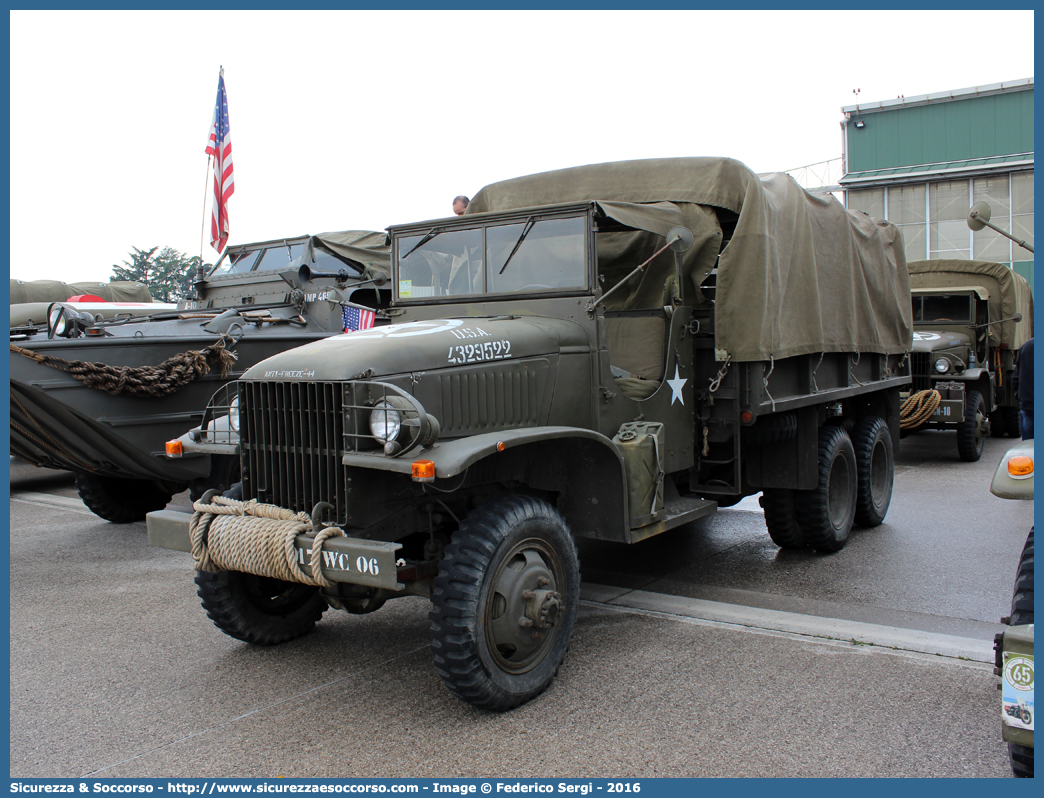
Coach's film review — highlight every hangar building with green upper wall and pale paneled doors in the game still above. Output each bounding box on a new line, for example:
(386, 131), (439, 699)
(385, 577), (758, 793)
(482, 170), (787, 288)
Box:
(839, 77), (1034, 286)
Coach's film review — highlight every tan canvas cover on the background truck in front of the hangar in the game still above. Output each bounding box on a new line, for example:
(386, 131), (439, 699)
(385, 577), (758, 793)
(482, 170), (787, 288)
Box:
(909, 260), (1034, 349)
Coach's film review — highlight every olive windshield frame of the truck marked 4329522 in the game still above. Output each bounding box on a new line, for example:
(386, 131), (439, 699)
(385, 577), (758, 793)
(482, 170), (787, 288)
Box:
(388, 203), (596, 306)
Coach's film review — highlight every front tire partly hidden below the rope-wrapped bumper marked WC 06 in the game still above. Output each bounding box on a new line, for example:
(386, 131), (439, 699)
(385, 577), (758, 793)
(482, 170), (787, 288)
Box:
(195, 570), (328, 646)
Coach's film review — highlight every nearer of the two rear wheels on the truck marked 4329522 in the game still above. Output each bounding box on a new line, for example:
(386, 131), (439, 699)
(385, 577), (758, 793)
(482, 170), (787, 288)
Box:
(798, 424), (858, 551)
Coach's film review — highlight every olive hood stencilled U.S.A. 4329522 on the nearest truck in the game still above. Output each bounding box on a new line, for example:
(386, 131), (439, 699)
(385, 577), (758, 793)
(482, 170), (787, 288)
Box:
(242, 316), (591, 381)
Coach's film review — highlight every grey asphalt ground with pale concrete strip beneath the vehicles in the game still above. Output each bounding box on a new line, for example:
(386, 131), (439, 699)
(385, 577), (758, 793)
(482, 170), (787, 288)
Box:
(10, 435), (1031, 777)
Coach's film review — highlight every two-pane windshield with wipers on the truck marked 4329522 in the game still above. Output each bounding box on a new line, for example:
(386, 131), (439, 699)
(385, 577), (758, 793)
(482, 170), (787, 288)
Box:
(397, 216), (588, 299)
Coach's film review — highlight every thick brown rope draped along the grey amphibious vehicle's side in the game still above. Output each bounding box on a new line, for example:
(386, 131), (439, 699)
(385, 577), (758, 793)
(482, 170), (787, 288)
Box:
(10, 335), (236, 397)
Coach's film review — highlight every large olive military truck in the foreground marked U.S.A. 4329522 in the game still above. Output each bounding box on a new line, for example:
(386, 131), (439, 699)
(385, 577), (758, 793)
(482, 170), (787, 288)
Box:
(148, 159), (911, 710)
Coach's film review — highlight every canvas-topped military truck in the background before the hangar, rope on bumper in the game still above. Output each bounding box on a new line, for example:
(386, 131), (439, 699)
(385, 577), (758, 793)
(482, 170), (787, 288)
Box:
(903, 260), (1034, 462)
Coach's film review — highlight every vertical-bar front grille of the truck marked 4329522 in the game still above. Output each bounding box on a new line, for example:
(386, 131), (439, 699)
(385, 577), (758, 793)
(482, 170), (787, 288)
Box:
(239, 381), (348, 525)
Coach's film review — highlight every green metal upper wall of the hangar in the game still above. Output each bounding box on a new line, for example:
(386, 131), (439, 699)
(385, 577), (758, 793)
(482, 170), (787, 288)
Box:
(848, 89), (1034, 172)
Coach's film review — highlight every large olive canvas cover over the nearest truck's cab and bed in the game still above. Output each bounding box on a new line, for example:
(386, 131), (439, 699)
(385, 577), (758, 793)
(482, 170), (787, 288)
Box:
(468, 158), (912, 361)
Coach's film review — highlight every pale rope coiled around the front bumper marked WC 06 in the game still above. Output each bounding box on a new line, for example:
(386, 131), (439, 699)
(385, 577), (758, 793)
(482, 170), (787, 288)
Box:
(189, 496), (345, 587)
